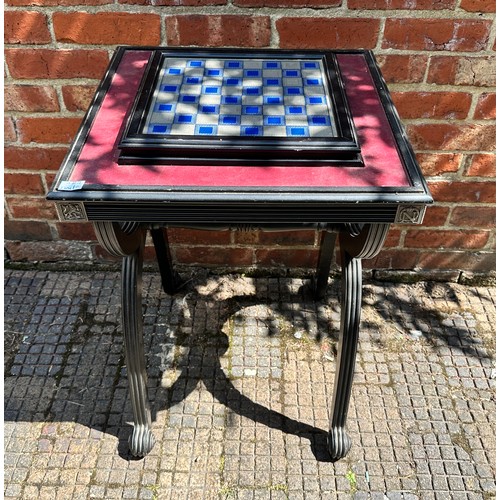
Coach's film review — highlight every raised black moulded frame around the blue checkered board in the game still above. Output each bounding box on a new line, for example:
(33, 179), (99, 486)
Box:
(118, 48), (363, 166)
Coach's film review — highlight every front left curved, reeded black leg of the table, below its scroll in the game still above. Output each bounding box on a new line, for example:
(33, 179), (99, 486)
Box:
(122, 232), (154, 457)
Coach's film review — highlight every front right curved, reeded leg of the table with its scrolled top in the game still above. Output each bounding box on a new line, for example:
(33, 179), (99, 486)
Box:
(328, 224), (389, 460)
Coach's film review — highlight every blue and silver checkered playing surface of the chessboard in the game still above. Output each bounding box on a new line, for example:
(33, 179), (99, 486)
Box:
(143, 58), (338, 138)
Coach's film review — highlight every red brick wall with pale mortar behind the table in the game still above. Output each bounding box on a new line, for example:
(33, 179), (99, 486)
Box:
(5, 0), (495, 272)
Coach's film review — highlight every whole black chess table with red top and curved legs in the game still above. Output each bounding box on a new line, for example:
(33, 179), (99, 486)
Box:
(47, 47), (432, 460)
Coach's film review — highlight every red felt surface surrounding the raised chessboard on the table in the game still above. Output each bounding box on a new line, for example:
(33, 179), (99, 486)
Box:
(69, 50), (410, 190)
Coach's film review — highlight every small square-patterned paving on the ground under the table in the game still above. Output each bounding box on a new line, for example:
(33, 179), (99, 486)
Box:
(4, 270), (495, 500)
